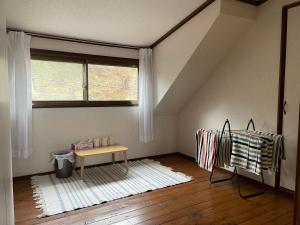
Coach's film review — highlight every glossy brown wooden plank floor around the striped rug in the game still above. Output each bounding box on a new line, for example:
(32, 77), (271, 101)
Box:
(14, 155), (293, 225)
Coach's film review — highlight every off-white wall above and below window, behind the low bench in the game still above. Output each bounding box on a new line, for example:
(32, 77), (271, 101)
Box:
(13, 38), (176, 177)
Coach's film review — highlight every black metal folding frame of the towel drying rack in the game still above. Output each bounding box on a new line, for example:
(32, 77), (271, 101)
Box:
(209, 119), (265, 199)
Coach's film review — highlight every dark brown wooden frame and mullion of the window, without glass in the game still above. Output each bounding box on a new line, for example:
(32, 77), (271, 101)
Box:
(30, 49), (139, 108)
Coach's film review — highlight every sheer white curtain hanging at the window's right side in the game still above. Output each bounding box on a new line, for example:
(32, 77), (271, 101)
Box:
(139, 49), (154, 143)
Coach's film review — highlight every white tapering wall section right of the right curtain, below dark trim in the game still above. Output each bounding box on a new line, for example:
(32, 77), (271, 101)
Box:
(153, 0), (221, 104)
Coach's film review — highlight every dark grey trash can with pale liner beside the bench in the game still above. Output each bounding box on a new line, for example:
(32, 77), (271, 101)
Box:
(52, 150), (74, 178)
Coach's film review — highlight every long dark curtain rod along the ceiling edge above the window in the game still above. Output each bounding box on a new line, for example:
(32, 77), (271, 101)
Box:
(6, 27), (149, 50)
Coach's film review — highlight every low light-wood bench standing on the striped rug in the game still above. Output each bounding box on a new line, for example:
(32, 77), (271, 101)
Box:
(75, 145), (128, 179)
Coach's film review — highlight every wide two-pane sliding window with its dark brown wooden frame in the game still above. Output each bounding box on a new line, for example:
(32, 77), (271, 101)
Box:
(31, 49), (138, 108)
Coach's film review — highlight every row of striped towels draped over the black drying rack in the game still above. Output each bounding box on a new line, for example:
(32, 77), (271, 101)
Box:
(196, 129), (286, 175)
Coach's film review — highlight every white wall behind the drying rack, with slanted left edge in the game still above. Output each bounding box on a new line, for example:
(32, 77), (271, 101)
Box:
(178, 0), (296, 189)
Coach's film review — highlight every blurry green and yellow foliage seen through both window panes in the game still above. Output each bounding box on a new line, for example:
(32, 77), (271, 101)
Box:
(31, 60), (138, 101)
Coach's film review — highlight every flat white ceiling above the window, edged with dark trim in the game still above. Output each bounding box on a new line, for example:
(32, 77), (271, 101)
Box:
(6, 0), (205, 46)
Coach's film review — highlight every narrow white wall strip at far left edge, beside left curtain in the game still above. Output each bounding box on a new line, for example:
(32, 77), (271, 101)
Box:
(0, 2), (14, 225)
